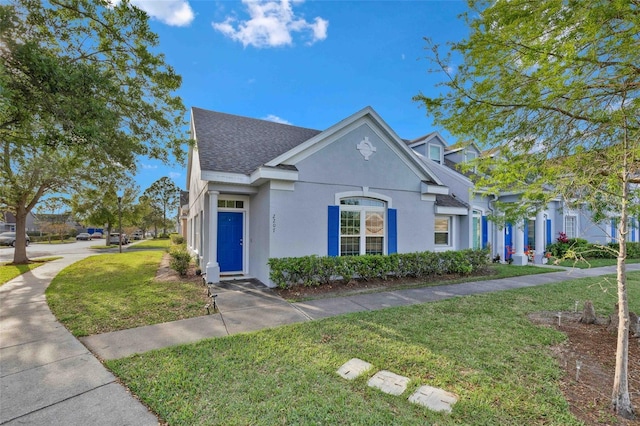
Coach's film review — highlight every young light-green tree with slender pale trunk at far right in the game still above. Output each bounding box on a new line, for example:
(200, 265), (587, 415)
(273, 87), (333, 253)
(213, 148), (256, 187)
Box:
(415, 0), (640, 418)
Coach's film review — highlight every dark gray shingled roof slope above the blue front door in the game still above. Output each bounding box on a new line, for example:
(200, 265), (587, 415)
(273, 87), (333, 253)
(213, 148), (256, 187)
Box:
(192, 107), (321, 174)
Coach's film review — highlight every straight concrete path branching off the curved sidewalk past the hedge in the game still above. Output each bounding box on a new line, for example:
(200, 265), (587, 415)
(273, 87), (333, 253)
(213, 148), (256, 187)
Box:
(81, 264), (640, 360)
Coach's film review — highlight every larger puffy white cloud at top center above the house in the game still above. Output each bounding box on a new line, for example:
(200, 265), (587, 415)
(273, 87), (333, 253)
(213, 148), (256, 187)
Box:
(211, 0), (329, 47)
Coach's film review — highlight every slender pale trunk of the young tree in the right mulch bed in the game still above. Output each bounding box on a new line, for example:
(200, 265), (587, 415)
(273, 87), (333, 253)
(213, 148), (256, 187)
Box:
(611, 168), (635, 419)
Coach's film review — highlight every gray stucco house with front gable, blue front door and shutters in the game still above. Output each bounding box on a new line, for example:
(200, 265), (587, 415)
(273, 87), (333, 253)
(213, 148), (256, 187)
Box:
(183, 107), (473, 284)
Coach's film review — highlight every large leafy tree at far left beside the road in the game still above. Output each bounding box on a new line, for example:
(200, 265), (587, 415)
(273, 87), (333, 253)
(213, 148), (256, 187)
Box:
(0, 0), (185, 263)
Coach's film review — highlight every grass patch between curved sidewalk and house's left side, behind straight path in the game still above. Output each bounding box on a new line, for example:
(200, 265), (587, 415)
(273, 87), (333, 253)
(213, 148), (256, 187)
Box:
(46, 251), (206, 336)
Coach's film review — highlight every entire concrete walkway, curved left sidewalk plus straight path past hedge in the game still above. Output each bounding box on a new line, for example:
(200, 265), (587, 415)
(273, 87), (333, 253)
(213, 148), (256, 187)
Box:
(0, 255), (640, 425)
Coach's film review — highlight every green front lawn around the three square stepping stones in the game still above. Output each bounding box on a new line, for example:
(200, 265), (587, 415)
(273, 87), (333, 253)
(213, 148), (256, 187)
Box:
(107, 272), (640, 425)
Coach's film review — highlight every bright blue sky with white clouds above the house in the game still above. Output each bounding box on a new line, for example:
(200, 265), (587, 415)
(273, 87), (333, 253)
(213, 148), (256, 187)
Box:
(131, 0), (468, 190)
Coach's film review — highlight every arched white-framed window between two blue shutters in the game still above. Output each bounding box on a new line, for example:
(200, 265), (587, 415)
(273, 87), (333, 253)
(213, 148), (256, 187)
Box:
(340, 197), (386, 256)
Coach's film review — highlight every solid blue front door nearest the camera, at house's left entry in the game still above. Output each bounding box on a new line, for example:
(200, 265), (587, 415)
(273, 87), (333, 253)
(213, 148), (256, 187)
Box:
(218, 212), (244, 272)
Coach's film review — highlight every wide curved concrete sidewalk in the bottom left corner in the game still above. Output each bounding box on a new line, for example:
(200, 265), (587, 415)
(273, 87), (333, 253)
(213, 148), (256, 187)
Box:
(0, 255), (158, 426)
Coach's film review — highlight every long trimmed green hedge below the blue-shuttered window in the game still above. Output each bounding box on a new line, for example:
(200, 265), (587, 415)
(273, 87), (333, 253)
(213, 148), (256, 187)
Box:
(268, 249), (489, 288)
